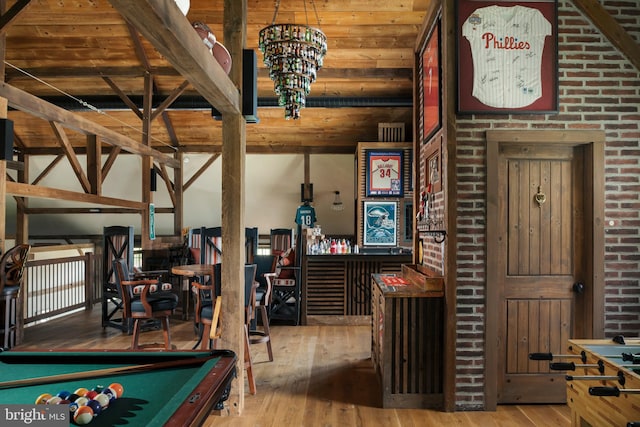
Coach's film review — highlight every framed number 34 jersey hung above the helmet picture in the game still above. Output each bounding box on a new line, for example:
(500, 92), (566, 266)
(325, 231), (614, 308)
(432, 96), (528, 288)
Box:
(365, 150), (403, 196)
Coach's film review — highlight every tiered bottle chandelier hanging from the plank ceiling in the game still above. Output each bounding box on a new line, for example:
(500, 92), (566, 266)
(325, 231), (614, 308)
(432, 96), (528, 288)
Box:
(258, 0), (327, 120)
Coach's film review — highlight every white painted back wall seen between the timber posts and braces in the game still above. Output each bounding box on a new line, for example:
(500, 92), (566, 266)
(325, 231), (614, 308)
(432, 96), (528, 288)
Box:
(7, 154), (355, 236)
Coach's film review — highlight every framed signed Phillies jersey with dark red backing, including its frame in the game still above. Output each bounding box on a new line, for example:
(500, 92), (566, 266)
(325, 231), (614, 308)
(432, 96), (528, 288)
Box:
(456, 0), (558, 114)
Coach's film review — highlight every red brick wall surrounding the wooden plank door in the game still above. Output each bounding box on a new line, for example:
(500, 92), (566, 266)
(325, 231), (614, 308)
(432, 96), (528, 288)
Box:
(456, 0), (640, 409)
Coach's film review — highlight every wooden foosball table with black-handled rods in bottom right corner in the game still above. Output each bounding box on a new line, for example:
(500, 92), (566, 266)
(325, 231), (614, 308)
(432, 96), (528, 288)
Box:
(529, 336), (640, 427)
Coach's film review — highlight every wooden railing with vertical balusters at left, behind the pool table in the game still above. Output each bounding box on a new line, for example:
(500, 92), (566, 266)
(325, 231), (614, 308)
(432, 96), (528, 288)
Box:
(23, 245), (102, 325)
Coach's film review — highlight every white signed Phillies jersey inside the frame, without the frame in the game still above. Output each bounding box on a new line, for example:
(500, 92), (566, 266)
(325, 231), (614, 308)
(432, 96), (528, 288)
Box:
(462, 6), (551, 108)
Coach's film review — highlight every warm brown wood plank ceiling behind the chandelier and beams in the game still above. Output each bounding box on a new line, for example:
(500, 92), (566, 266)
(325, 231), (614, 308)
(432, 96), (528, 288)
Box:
(2, 0), (430, 154)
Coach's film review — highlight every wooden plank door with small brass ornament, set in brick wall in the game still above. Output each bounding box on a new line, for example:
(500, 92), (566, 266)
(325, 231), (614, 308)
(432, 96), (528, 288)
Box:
(497, 144), (585, 403)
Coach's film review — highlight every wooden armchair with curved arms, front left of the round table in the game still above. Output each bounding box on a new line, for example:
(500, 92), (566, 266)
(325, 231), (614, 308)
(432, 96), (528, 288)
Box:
(113, 259), (178, 350)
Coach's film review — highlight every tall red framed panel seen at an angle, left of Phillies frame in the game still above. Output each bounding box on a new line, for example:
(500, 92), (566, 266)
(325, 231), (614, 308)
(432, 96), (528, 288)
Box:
(420, 18), (442, 142)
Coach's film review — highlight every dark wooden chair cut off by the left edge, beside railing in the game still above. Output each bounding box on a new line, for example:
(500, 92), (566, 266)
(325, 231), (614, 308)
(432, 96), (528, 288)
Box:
(0, 245), (31, 348)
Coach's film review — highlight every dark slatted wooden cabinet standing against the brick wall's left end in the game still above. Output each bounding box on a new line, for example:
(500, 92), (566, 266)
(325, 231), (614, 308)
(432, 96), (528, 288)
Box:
(371, 274), (444, 409)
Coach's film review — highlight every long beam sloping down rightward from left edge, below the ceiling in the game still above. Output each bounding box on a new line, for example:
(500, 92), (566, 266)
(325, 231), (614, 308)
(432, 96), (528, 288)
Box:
(0, 83), (180, 168)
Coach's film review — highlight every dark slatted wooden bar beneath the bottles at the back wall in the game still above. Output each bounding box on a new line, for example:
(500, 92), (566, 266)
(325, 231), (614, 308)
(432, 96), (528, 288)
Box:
(302, 253), (411, 325)
